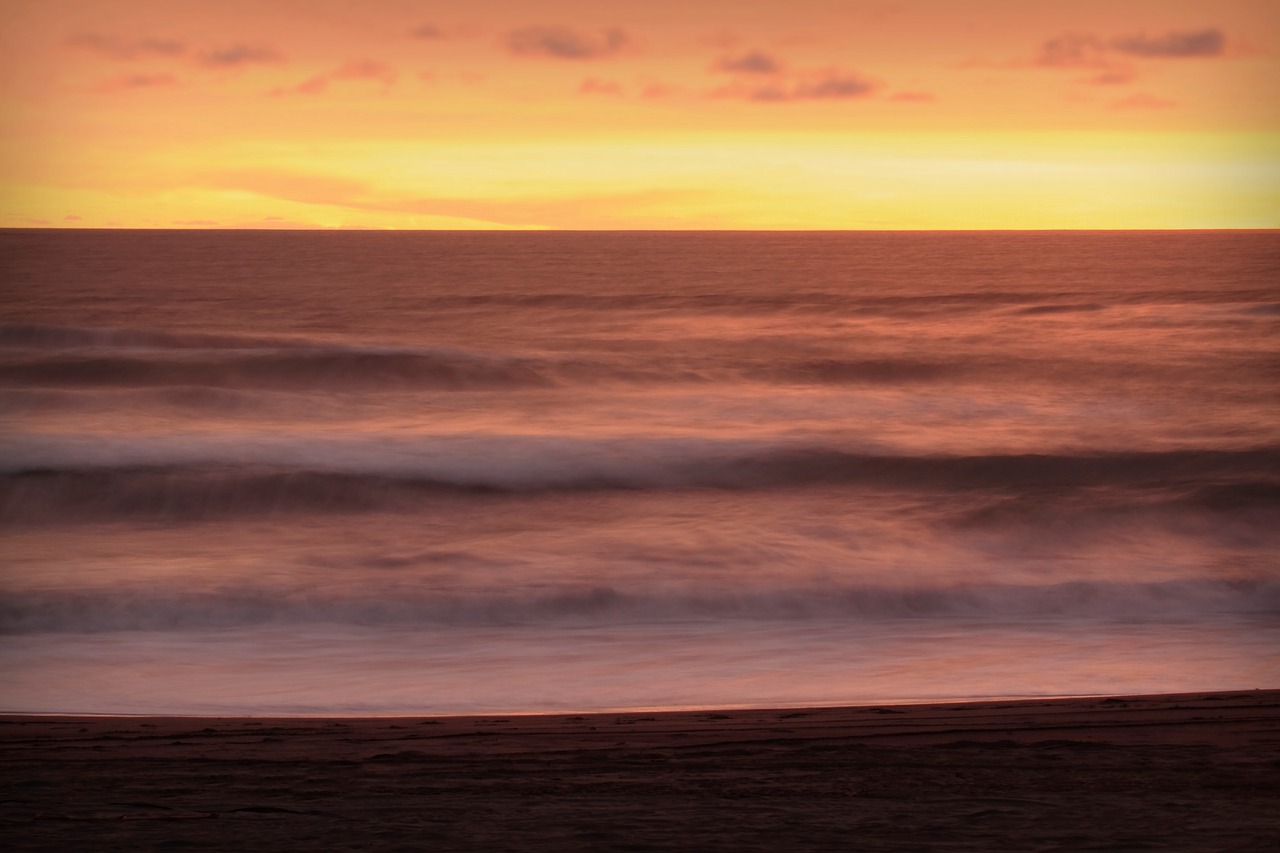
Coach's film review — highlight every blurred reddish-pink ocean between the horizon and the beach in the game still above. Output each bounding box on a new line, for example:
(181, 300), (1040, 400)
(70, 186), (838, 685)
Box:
(0, 231), (1280, 715)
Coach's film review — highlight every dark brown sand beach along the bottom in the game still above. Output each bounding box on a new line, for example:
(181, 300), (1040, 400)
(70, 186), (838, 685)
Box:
(0, 690), (1280, 853)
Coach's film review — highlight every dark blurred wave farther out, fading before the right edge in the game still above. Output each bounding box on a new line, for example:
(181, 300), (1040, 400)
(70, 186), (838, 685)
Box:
(0, 324), (988, 391)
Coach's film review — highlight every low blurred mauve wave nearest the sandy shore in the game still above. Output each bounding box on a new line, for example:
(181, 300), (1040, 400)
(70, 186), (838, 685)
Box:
(0, 578), (1280, 634)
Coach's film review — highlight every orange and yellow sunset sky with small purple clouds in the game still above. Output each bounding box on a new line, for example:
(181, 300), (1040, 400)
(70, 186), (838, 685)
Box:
(0, 0), (1280, 229)
